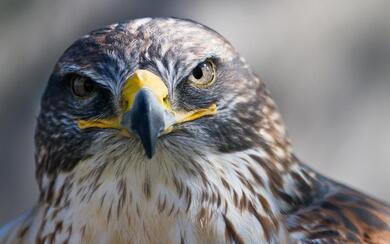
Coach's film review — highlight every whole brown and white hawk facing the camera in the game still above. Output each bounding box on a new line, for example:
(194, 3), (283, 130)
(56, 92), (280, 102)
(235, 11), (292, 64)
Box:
(0, 18), (390, 244)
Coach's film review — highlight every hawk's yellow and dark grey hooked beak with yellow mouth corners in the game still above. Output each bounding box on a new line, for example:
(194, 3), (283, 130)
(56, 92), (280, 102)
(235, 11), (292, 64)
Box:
(78, 69), (217, 158)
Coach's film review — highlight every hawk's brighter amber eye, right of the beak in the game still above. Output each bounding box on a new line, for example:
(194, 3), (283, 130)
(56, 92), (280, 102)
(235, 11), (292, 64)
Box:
(188, 60), (216, 88)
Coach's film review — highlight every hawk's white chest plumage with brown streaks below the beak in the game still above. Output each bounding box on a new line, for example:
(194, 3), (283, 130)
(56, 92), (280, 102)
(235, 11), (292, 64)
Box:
(3, 148), (285, 243)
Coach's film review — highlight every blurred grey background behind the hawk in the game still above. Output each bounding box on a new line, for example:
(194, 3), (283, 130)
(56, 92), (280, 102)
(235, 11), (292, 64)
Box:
(0, 0), (390, 225)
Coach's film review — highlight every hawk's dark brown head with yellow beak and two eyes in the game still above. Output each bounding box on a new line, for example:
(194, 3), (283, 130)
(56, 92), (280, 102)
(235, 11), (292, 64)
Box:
(36, 18), (288, 184)
